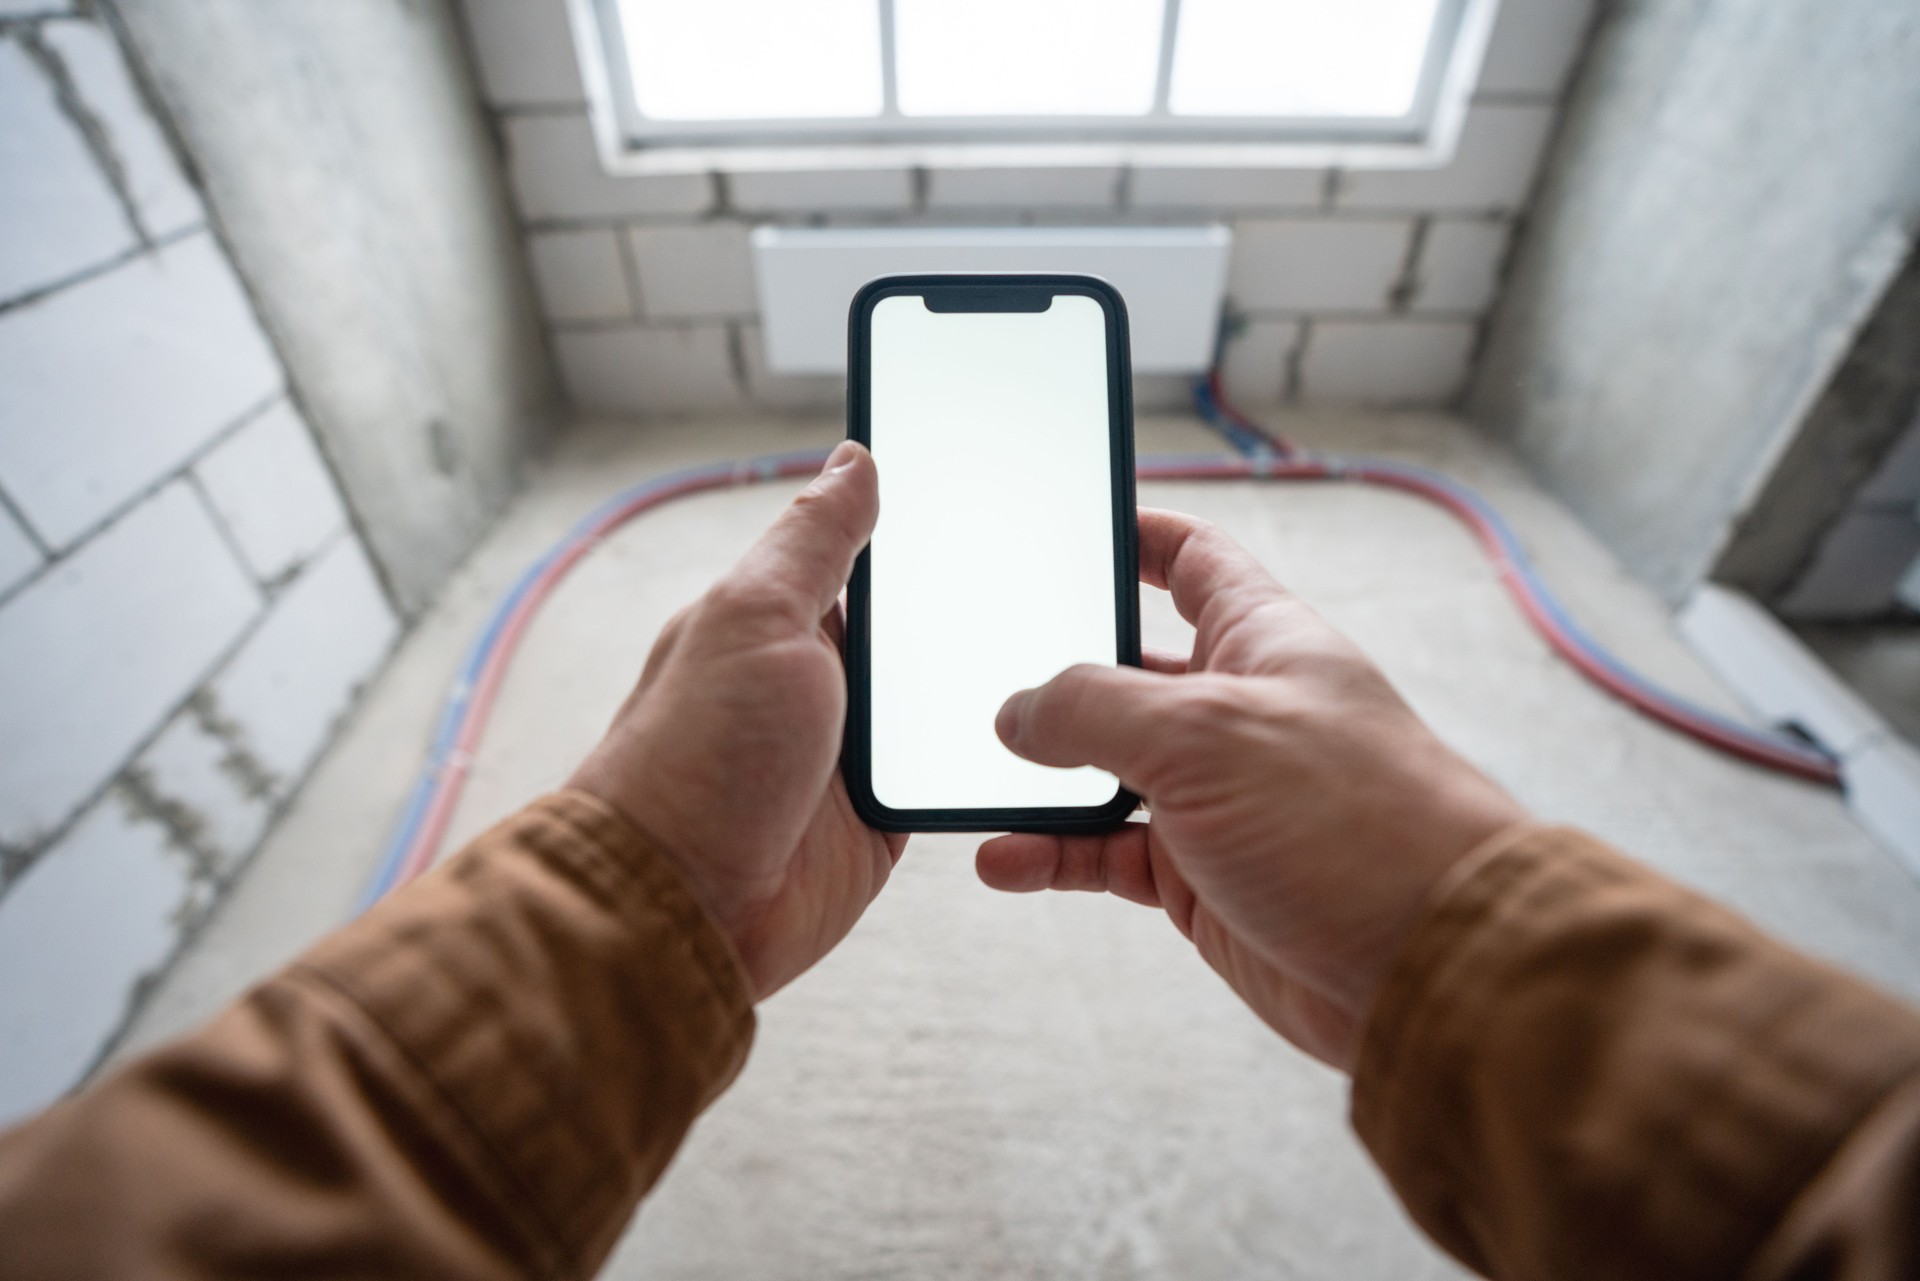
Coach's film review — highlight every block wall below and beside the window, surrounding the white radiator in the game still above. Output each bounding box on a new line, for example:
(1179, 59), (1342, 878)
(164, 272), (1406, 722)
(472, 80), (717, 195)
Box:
(463, 0), (1594, 415)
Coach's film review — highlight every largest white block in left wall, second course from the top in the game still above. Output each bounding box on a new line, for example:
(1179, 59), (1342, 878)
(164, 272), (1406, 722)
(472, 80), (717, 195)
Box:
(0, 234), (282, 547)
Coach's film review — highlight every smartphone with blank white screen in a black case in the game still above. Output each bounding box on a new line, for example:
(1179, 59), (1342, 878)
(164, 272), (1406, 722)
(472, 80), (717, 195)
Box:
(841, 275), (1140, 832)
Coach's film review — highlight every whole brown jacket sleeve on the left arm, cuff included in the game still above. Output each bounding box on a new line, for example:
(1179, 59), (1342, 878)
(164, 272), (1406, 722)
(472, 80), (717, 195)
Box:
(0, 793), (753, 1279)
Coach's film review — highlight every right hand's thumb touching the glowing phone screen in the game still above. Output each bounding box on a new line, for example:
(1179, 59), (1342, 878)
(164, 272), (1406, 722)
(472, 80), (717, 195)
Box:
(993, 663), (1181, 784)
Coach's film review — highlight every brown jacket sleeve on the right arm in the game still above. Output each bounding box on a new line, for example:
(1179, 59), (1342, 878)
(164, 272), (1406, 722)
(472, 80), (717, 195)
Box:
(1354, 828), (1920, 1281)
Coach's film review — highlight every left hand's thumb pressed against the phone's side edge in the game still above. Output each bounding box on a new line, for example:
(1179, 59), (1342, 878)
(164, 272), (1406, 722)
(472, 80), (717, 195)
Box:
(718, 440), (879, 624)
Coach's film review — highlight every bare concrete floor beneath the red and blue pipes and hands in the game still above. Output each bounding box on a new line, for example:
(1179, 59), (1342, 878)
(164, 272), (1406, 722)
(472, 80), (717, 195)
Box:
(116, 415), (1920, 1279)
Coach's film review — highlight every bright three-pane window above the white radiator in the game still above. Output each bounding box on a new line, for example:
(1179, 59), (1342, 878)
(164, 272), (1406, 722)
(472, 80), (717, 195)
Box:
(591, 0), (1498, 165)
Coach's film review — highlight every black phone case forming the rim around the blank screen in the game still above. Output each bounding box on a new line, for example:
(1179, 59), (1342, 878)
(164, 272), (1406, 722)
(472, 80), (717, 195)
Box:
(841, 273), (1140, 834)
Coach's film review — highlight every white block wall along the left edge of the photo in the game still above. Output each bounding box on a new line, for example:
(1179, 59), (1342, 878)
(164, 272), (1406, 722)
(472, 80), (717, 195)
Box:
(0, 0), (396, 1124)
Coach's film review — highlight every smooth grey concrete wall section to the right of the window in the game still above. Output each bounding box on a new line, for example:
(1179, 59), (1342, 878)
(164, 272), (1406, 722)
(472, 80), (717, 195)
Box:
(1475, 0), (1920, 601)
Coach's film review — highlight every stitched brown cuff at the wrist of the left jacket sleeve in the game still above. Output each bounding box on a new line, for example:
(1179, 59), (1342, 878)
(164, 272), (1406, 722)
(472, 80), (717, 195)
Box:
(296, 791), (755, 1269)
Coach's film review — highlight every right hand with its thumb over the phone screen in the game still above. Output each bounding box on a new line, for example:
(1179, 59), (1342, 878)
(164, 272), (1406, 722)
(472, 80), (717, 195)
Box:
(979, 509), (1526, 1068)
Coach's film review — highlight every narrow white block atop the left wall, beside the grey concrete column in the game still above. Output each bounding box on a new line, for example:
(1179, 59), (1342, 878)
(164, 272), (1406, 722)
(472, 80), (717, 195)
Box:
(40, 23), (205, 236)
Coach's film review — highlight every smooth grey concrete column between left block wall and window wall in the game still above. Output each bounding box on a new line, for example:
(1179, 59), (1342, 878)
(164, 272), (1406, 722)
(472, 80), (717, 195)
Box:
(116, 0), (559, 616)
